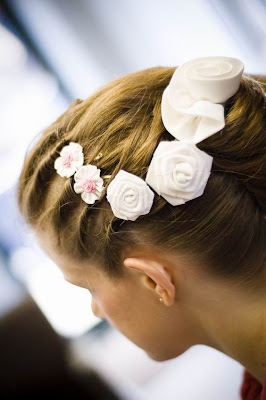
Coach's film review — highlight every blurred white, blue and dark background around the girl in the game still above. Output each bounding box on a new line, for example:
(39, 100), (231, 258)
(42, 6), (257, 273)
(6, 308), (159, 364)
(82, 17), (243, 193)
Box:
(0, 0), (266, 400)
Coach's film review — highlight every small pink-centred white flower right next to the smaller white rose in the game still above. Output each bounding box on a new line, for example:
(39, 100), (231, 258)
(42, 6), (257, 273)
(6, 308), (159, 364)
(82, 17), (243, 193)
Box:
(74, 164), (104, 204)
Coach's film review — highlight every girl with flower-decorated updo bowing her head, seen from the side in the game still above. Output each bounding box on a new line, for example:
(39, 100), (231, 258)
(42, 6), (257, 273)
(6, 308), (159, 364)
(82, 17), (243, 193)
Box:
(18, 57), (266, 400)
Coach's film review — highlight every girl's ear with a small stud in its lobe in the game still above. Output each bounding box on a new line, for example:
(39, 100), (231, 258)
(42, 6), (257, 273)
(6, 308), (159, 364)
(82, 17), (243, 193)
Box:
(124, 257), (175, 306)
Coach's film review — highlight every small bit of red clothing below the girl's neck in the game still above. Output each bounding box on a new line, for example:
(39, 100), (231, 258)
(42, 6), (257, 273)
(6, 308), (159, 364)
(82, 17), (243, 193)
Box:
(240, 369), (266, 400)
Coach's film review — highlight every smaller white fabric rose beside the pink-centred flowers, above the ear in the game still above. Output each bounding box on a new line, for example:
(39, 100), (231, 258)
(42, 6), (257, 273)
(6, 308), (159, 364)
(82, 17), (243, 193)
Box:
(106, 169), (154, 221)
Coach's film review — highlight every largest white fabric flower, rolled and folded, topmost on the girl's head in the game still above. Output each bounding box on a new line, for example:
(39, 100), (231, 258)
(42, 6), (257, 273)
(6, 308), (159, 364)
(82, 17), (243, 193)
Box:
(161, 57), (244, 144)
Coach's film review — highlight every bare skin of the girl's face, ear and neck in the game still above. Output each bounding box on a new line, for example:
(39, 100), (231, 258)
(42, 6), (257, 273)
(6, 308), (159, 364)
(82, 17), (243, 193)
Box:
(36, 231), (266, 384)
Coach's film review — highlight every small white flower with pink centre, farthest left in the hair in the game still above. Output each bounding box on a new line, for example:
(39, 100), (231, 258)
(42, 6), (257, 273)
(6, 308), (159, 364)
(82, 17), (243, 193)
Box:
(54, 142), (84, 178)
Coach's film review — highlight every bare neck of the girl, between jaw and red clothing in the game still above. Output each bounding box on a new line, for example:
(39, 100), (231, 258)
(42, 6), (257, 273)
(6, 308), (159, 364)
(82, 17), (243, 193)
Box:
(187, 280), (266, 384)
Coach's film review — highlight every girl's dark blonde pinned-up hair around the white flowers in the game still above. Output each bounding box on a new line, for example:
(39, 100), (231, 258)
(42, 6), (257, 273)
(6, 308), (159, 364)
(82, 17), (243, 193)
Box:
(17, 67), (266, 288)
